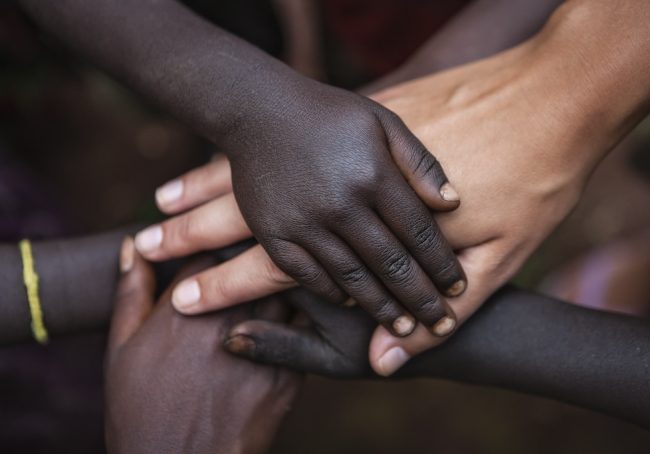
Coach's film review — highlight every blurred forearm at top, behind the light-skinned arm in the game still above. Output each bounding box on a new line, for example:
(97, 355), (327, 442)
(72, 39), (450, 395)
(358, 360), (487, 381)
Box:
(363, 0), (563, 93)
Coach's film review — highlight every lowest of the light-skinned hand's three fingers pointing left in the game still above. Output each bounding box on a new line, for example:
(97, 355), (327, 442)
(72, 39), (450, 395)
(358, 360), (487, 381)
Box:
(172, 245), (296, 315)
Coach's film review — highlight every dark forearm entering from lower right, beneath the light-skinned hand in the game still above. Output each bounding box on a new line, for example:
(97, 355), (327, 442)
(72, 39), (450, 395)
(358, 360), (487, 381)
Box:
(404, 288), (650, 427)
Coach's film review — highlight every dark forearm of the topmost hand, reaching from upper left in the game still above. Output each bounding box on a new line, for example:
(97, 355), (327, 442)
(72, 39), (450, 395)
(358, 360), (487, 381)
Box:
(21, 0), (295, 151)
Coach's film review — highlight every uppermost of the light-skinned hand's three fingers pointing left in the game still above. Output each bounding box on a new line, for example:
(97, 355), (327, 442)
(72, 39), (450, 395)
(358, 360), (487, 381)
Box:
(156, 155), (232, 214)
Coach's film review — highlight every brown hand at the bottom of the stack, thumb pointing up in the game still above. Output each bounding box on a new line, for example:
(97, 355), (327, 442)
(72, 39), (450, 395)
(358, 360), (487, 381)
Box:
(106, 240), (300, 453)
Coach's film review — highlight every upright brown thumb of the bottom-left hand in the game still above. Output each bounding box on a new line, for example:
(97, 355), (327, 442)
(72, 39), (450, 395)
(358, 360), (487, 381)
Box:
(108, 237), (155, 352)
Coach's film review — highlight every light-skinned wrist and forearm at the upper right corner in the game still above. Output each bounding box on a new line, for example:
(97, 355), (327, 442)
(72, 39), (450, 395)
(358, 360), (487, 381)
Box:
(530, 0), (650, 174)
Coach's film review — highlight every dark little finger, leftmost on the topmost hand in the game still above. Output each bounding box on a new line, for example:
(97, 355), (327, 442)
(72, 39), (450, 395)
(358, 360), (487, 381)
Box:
(264, 240), (347, 304)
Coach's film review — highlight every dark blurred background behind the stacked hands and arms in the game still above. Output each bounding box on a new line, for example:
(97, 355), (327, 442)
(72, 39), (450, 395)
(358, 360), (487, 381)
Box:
(0, 0), (650, 454)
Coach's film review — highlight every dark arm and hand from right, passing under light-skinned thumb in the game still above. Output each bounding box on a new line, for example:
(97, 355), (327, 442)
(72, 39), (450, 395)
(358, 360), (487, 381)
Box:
(226, 287), (650, 428)
